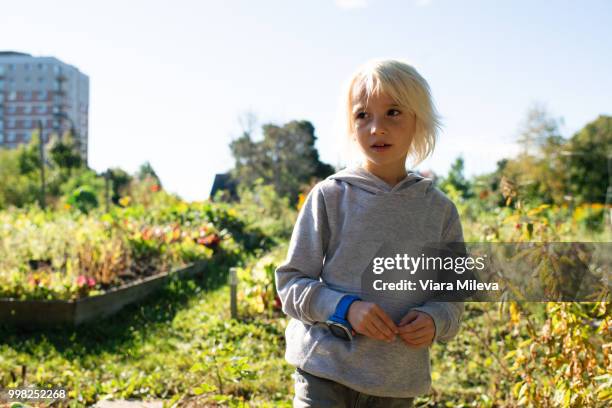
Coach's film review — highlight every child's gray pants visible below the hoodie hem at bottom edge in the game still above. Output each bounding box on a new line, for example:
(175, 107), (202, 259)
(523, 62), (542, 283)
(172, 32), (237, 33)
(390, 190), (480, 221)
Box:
(293, 368), (413, 408)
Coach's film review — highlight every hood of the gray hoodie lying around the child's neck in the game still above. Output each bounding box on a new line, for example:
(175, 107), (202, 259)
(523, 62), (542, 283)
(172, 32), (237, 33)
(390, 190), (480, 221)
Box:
(327, 166), (433, 197)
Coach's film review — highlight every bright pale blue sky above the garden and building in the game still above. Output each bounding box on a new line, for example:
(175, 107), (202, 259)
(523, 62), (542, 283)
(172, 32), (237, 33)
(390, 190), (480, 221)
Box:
(0, 0), (612, 200)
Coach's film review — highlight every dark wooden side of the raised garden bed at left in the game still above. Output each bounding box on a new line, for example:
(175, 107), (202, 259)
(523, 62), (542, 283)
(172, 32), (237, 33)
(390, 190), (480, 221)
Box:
(0, 261), (208, 328)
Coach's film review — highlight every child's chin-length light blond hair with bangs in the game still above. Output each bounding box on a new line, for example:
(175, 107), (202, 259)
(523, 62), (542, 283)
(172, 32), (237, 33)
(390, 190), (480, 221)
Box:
(342, 60), (441, 165)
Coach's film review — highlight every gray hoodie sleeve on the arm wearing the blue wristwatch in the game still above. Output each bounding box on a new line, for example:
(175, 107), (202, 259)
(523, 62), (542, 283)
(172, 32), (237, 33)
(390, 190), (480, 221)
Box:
(275, 183), (345, 324)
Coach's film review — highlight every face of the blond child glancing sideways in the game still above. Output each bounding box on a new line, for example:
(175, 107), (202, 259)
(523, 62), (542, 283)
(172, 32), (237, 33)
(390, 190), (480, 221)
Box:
(352, 92), (416, 170)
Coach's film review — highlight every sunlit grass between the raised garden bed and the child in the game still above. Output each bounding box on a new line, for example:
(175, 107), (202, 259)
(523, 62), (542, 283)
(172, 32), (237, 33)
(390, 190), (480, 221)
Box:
(0, 272), (292, 407)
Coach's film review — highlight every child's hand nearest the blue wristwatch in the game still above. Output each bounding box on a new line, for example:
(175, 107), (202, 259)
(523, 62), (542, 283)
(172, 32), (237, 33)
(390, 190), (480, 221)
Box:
(346, 300), (398, 342)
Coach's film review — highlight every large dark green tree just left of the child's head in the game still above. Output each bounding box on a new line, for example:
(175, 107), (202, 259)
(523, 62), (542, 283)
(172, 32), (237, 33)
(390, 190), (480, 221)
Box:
(230, 121), (334, 204)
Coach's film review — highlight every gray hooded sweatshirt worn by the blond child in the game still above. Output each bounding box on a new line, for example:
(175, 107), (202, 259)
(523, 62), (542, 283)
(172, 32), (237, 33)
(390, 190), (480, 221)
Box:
(275, 167), (464, 398)
